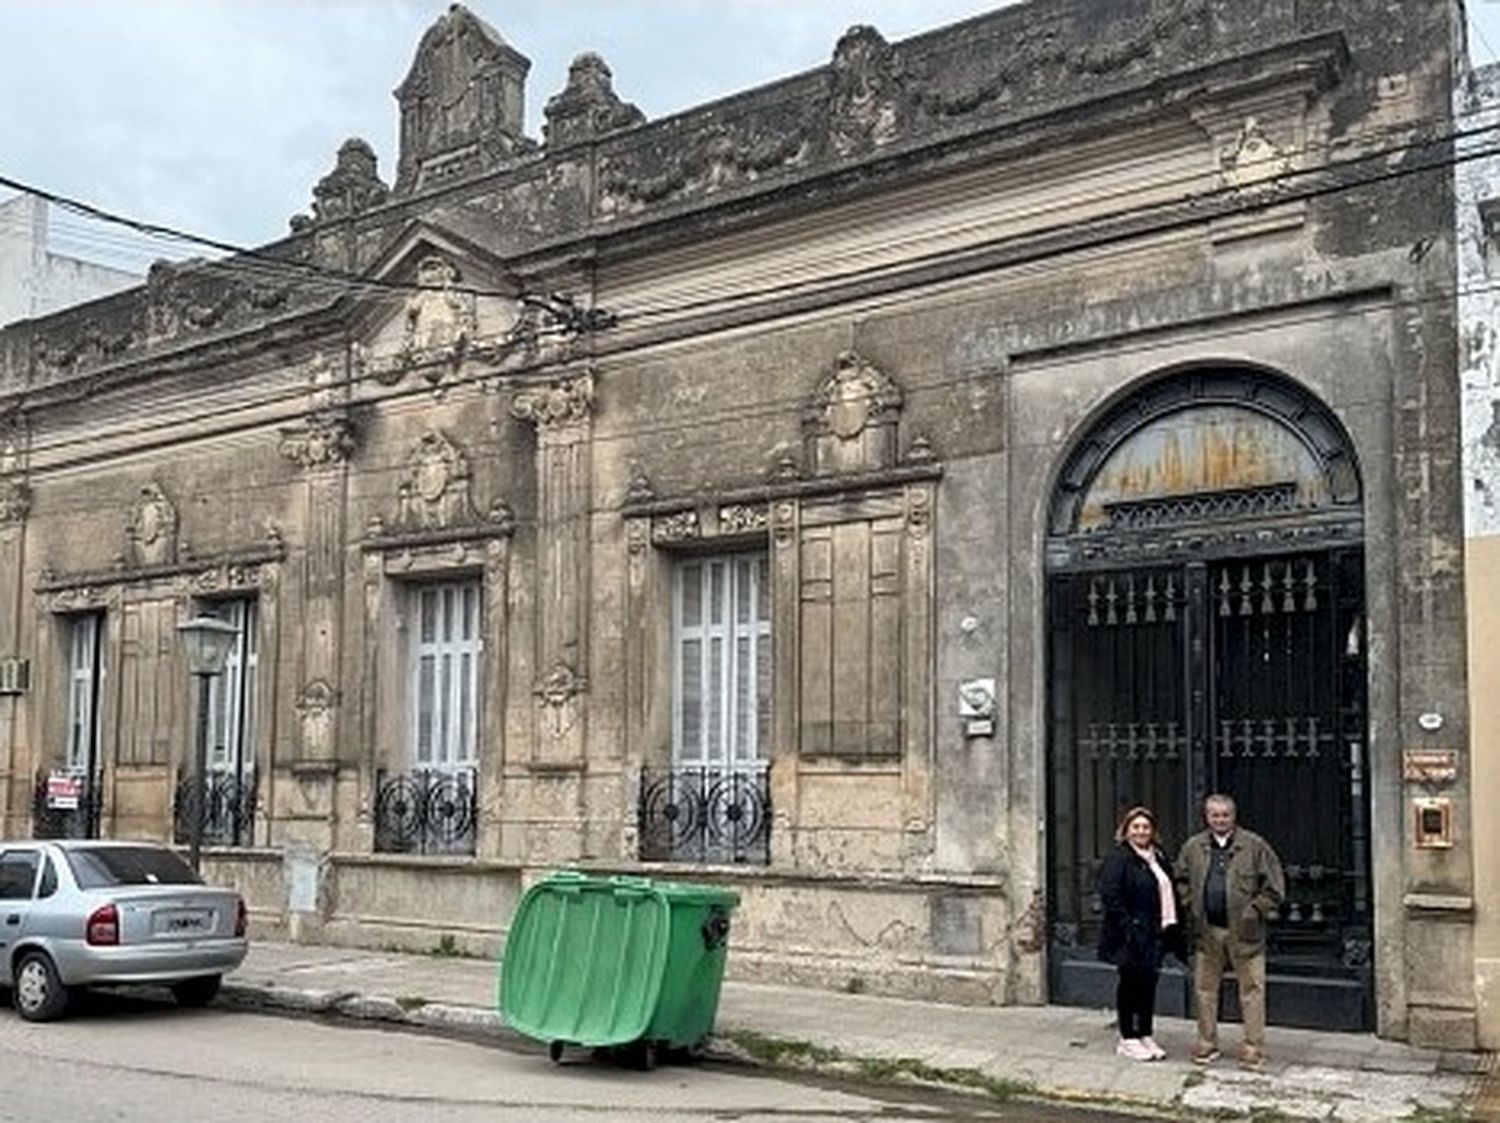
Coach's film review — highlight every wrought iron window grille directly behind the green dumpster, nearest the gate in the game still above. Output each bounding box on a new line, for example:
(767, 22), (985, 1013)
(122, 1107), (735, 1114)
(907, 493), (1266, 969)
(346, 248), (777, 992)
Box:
(638, 766), (771, 865)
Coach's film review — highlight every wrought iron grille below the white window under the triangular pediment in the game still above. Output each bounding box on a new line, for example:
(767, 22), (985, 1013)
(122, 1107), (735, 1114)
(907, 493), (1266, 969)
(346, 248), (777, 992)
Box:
(375, 768), (479, 855)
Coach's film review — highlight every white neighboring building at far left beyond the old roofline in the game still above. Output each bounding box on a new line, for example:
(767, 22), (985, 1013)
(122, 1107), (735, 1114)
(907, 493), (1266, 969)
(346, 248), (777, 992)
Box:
(0, 195), (141, 324)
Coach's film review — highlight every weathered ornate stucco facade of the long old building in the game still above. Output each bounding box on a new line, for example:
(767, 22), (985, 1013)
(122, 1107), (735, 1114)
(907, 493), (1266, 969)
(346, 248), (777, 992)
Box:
(0, 0), (1479, 1048)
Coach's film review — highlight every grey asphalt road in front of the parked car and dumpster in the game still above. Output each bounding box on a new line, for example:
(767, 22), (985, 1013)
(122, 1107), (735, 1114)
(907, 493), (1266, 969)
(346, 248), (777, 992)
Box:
(0, 996), (1146, 1123)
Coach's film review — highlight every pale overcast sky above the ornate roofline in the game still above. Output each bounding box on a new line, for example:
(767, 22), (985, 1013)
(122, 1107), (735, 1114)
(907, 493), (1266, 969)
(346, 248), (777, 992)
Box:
(0, 0), (1500, 268)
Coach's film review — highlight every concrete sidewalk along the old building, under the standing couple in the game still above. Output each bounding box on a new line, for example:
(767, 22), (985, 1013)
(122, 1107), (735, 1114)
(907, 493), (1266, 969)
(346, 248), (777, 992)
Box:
(222, 943), (1494, 1123)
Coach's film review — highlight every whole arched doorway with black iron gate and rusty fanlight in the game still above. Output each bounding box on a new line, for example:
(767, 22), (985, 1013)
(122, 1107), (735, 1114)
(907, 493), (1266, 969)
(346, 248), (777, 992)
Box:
(1047, 367), (1374, 1029)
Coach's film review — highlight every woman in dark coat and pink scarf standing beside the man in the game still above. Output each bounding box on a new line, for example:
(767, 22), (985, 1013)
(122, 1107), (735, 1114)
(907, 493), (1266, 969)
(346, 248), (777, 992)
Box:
(1100, 807), (1184, 1060)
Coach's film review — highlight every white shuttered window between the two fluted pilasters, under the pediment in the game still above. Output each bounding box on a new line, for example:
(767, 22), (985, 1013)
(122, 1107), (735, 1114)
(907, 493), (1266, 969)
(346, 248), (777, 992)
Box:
(408, 582), (483, 769)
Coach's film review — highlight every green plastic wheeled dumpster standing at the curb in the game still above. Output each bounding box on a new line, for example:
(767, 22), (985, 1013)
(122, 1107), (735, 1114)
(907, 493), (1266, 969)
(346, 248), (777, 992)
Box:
(500, 871), (740, 1068)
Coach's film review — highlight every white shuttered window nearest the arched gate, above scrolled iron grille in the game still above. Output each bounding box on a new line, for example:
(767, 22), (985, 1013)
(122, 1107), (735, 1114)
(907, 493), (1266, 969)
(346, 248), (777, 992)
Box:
(672, 553), (771, 769)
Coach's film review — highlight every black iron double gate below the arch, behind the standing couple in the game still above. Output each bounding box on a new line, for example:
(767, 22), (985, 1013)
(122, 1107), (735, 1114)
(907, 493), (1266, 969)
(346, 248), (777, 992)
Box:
(1047, 547), (1374, 1029)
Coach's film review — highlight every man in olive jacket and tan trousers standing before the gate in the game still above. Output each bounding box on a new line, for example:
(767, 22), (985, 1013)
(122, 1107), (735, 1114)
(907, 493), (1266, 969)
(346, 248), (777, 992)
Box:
(1176, 793), (1286, 1069)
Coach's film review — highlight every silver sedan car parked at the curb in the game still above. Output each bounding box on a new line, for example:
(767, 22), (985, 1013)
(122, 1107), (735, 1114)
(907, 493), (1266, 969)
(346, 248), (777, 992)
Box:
(0, 840), (248, 1021)
